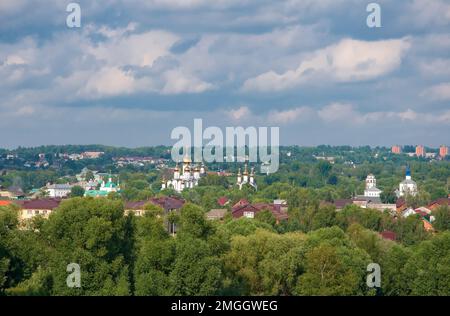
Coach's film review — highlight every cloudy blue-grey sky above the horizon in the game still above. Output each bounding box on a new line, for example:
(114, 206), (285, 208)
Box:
(0, 0), (450, 148)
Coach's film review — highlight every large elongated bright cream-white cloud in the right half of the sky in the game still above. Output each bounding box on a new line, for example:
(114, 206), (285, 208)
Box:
(243, 38), (410, 91)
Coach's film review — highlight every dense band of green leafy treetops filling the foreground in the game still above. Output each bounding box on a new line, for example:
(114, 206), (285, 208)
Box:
(0, 198), (450, 295)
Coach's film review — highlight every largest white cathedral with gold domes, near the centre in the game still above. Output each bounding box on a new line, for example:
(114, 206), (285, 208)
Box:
(161, 156), (206, 192)
